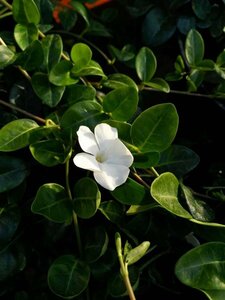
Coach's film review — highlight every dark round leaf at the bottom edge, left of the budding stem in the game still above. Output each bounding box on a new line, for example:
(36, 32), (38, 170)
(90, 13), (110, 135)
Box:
(48, 255), (90, 299)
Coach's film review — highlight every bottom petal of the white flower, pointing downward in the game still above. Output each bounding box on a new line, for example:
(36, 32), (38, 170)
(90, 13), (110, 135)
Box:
(94, 164), (130, 191)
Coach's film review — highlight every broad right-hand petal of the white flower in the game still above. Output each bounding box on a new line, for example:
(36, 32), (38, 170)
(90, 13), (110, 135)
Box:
(101, 139), (134, 167)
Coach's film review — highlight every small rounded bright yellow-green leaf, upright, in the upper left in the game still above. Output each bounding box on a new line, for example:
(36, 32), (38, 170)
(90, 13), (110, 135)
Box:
(70, 43), (92, 72)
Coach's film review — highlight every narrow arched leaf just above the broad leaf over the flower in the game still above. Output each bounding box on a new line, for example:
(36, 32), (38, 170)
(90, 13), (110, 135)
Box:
(102, 73), (138, 92)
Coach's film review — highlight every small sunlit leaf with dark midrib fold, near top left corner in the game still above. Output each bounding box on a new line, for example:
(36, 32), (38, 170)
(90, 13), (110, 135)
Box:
(14, 23), (38, 50)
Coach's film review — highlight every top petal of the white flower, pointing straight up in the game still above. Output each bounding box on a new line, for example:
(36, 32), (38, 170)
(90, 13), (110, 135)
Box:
(94, 123), (118, 148)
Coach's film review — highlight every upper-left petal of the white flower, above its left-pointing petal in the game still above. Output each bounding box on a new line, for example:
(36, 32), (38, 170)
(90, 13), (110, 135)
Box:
(77, 126), (99, 155)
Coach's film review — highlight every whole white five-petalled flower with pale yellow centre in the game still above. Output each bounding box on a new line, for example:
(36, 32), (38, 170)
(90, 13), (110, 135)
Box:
(73, 123), (133, 191)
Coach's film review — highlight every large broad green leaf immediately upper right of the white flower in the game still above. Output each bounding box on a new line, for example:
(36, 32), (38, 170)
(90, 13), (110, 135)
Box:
(131, 103), (179, 153)
